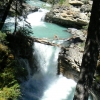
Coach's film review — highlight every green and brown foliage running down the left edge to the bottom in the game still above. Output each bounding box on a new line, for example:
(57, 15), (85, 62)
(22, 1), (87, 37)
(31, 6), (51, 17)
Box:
(0, 32), (20, 100)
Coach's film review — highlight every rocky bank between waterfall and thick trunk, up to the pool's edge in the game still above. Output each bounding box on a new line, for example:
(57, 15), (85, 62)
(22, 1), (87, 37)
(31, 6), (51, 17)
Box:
(58, 28), (86, 81)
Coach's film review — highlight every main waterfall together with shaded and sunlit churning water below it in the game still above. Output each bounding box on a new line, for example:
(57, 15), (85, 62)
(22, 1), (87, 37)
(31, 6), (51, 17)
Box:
(20, 43), (76, 100)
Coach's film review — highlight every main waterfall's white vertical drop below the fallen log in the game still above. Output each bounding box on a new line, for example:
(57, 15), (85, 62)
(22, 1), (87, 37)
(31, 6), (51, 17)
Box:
(34, 43), (60, 75)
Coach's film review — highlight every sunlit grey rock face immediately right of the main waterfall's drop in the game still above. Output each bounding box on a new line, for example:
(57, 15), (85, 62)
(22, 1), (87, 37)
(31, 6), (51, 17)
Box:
(58, 44), (83, 81)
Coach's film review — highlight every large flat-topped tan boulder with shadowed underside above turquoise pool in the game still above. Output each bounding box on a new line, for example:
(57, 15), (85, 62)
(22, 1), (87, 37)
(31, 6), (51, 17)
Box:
(45, 6), (89, 28)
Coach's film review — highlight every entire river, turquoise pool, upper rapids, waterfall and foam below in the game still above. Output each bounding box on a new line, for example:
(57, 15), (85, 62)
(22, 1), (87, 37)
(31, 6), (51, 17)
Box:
(3, 0), (92, 100)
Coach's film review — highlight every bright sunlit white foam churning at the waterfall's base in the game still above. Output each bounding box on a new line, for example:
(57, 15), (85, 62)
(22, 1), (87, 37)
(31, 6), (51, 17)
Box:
(41, 75), (76, 100)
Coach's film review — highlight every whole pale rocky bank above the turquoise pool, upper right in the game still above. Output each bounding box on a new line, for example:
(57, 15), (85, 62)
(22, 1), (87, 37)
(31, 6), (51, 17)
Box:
(45, 0), (92, 28)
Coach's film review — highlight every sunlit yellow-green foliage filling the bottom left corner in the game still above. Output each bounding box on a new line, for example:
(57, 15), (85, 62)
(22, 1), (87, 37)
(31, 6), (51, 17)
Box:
(0, 61), (20, 100)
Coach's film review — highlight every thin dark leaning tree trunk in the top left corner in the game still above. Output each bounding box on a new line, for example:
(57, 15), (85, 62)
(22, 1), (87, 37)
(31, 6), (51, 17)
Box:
(0, 0), (13, 30)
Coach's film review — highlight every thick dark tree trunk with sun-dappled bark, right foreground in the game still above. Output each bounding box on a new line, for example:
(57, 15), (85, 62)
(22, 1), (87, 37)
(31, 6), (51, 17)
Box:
(73, 0), (100, 100)
